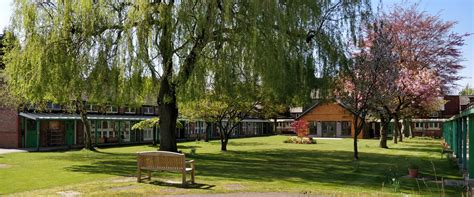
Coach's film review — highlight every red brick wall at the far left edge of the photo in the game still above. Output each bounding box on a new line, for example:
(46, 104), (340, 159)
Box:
(0, 108), (20, 148)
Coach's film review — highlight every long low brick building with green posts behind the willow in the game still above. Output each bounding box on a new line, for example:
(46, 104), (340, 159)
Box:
(0, 103), (273, 150)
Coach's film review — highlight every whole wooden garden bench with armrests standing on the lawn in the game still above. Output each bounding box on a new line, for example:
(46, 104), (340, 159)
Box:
(137, 151), (194, 186)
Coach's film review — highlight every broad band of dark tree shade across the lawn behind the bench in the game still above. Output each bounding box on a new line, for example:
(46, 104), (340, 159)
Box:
(66, 142), (462, 194)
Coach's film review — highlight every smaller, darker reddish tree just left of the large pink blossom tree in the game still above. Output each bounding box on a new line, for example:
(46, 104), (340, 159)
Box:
(335, 23), (397, 160)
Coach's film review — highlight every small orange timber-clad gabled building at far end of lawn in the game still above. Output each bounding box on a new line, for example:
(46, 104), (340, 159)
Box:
(296, 102), (364, 138)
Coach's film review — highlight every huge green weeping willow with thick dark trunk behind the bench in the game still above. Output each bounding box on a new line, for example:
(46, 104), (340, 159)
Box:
(6, 0), (370, 151)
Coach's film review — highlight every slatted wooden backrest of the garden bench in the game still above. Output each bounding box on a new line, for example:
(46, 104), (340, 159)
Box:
(137, 151), (186, 171)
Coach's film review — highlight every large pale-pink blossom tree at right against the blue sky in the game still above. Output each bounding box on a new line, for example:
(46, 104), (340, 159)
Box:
(381, 6), (469, 143)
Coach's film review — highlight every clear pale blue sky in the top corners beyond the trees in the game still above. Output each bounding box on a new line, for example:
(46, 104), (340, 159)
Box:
(0, 0), (474, 93)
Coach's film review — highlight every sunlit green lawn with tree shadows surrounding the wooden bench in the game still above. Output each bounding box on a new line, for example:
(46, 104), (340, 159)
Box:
(0, 136), (461, 196)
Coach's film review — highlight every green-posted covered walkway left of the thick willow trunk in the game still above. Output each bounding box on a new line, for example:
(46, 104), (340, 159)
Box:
(19, 112), (159, 151)
